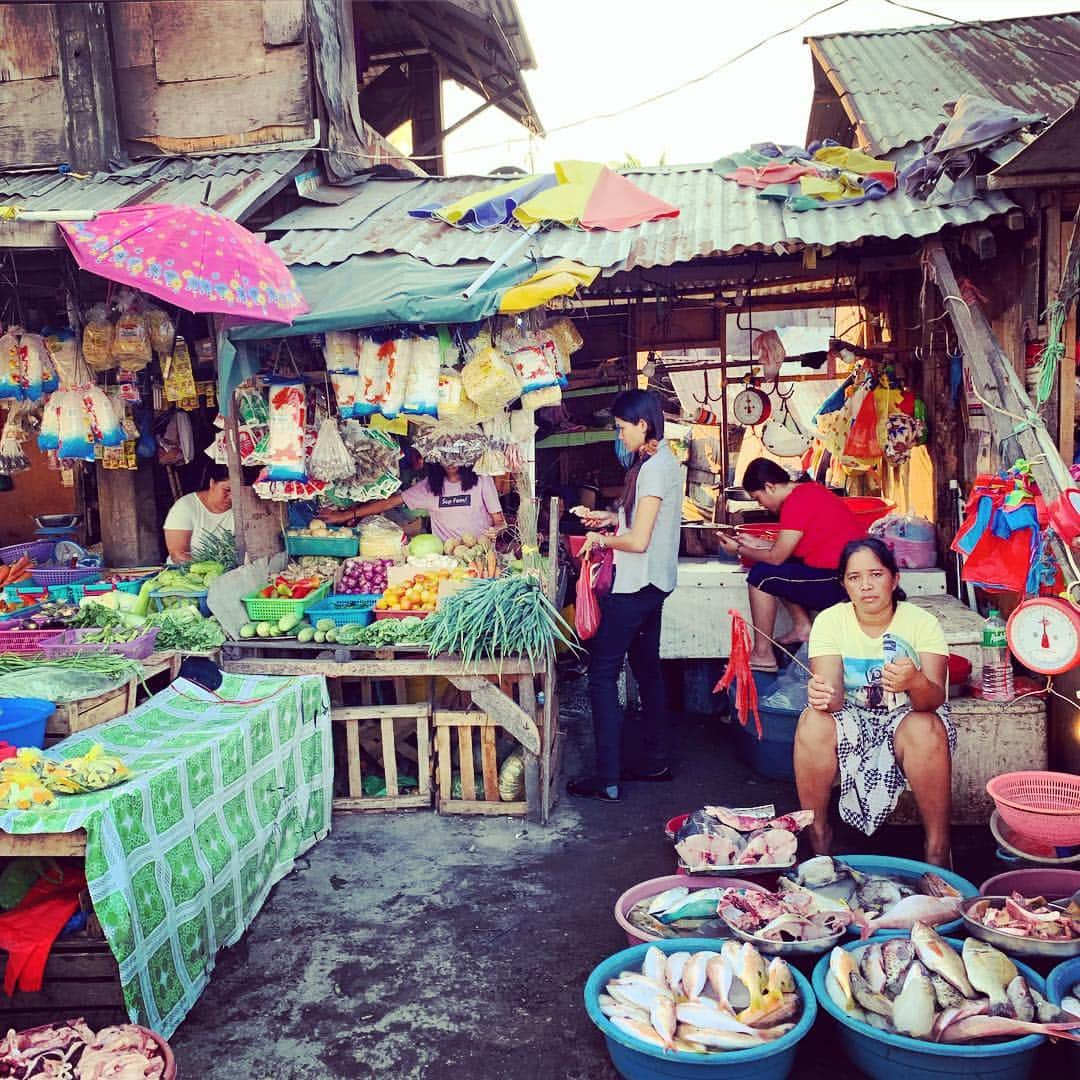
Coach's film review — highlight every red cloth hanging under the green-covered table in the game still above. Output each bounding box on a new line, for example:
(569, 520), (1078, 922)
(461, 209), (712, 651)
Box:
(0, 866), (86, 996)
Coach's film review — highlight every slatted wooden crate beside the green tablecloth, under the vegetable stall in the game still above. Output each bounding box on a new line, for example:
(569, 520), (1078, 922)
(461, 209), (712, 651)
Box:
(330, 702), (432, 810)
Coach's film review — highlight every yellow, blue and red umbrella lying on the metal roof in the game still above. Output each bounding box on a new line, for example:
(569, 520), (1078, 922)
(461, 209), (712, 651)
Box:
(409, 161), (678, 232)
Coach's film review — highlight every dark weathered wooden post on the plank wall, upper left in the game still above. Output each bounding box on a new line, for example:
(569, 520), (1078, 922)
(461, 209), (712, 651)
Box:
(52, 2), (120, 173)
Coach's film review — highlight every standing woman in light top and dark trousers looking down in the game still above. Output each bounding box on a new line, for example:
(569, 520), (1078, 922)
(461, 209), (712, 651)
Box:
(567, 390), (683, 802)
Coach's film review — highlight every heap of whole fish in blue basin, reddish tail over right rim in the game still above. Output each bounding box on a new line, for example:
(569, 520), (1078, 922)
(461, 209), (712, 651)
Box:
(825, 922), (1080, 1043)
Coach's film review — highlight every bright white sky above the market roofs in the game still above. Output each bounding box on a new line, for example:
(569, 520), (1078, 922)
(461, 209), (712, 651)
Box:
(444, 0), (1080, 174)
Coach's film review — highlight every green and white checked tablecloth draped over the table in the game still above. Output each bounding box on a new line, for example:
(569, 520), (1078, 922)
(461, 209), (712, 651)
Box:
(0, 675), (334, 1039)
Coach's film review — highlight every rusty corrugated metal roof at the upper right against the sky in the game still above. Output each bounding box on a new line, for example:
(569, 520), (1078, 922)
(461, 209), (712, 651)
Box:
(808, 12), (1080, 153)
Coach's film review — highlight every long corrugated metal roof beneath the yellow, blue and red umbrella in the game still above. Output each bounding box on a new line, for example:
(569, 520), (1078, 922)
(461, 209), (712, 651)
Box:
(267, 165), (1014, 275)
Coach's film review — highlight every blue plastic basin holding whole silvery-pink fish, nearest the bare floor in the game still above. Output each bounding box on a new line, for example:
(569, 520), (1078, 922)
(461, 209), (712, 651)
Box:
(585, 937), (818, 1080)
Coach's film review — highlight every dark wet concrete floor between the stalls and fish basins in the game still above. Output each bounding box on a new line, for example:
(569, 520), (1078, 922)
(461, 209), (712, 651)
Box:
(172, 680), (997, 1080)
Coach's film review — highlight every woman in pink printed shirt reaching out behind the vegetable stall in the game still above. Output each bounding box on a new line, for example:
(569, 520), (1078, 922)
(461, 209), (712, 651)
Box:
(319, 461), (507, 540)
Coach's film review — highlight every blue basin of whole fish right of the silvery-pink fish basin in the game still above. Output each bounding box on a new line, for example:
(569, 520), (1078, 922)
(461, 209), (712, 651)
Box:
(813, 934), (1047, 1080)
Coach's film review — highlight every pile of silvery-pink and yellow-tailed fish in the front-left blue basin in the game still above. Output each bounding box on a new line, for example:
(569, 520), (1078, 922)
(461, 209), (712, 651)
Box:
(596, 942), (802, 1054)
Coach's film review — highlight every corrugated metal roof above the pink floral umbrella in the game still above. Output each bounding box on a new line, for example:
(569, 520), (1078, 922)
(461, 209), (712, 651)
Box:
(0, 150), (307, 228)
